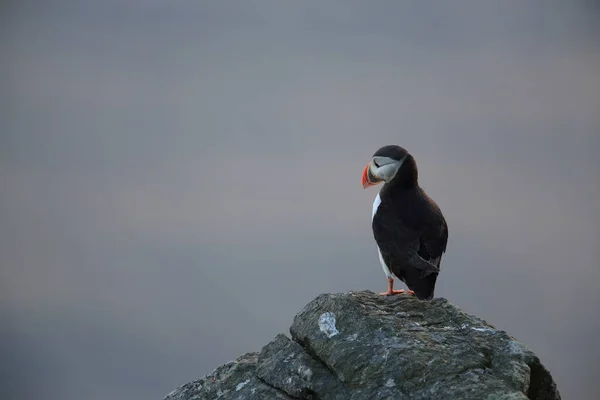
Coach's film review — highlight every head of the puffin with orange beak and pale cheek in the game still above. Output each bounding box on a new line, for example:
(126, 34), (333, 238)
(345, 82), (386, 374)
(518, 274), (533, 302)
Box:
(362, 145), (417, 189)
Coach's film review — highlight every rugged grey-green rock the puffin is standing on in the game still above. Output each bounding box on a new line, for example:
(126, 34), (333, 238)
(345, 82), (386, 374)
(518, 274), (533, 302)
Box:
(165, 291), (560, 400)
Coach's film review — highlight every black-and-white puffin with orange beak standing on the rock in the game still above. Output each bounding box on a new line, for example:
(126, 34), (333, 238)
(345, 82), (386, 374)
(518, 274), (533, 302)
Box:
(362, 145), (448, 300)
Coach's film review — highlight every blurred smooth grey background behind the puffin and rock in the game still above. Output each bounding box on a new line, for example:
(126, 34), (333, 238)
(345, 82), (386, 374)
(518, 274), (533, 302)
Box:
(0, 0), (600, 400)
